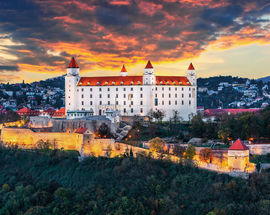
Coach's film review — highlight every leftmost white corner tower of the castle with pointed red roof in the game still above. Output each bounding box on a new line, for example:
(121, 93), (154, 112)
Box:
(65, 57), (80, 112)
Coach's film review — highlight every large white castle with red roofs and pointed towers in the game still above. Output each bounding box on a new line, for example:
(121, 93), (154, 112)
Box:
(65, 58), (197, 120)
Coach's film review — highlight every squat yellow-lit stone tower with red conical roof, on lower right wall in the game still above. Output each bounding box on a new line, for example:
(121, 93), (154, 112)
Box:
(228, 139), (249, 171)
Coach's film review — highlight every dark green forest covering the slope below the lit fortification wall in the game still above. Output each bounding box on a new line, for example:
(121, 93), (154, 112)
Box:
(0, 148), (270, 215)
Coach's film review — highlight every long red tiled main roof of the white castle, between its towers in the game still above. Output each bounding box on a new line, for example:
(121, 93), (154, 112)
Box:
(77, 76), (191, 86)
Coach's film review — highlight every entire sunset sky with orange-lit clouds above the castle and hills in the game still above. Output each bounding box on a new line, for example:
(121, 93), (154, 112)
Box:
(0, 0), (270, 83)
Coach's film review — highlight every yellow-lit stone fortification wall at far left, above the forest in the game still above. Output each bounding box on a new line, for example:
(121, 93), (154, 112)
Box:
(1, 128), (83, 151)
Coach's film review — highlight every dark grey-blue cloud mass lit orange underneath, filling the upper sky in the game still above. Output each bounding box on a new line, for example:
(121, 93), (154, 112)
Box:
(0, 0), (270, 78)
